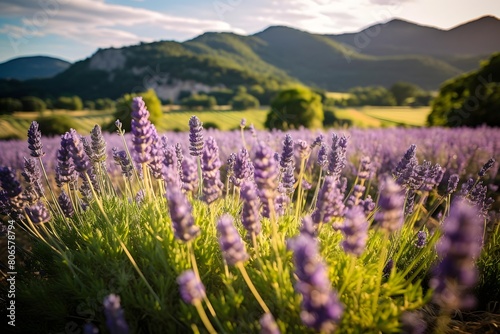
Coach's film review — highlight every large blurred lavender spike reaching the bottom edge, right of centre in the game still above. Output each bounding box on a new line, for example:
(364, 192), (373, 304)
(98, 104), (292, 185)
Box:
(288, 234), (343, 333)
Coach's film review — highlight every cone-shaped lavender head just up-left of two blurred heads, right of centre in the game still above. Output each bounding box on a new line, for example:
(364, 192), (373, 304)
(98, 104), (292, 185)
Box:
(312, 176), (345, 224)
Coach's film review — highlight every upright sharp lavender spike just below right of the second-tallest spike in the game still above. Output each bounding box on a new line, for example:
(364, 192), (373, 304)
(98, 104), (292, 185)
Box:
(201, 137), (224, 204)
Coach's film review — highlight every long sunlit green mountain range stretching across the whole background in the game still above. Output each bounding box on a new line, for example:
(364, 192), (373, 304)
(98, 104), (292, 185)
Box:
(0, 17), (500, 100)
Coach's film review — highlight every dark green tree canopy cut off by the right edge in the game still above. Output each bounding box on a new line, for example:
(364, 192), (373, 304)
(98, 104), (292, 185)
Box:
(427, 53), (500, 127)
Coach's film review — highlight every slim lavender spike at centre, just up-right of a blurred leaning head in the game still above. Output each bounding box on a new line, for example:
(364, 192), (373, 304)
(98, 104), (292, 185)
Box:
(241, 180), (262, 235)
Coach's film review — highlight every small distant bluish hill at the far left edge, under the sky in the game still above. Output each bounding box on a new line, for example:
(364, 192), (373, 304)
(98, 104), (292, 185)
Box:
(0, 56), (71, 80)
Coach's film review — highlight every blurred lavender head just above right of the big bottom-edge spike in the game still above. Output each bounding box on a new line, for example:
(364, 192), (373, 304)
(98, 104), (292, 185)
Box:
(341, 206), (369, 256)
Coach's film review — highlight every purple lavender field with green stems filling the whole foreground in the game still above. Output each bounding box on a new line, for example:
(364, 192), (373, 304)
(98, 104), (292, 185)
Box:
(0, 98), (500, 333)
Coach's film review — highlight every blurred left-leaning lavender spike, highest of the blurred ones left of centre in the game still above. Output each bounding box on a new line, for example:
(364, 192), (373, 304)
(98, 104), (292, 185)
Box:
(167, 187), (200, 242)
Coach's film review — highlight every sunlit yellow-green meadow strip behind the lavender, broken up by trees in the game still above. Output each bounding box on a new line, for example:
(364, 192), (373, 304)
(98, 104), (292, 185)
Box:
(0, 107), (430, 139)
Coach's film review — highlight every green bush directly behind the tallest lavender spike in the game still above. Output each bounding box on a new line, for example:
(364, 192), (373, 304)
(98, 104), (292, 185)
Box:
(111, 89), (163, 131)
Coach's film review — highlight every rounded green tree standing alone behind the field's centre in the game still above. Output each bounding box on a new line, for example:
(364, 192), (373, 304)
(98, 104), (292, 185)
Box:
(265, 87), (324, 130)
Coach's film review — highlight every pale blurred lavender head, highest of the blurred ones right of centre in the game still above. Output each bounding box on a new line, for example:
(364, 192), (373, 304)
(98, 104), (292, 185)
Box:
(375, 177), (404, 233)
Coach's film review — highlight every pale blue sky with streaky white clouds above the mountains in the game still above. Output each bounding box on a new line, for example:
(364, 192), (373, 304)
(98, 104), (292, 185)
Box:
(0, 0), (500, 62)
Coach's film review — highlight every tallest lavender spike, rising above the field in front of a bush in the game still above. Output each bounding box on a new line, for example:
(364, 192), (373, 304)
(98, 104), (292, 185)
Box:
(131, 96), (155, 164)
